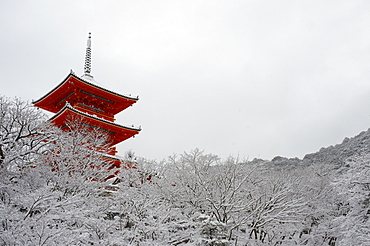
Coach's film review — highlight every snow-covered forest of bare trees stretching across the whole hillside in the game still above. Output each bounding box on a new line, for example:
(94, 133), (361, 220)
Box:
(0, 96), (370, 246)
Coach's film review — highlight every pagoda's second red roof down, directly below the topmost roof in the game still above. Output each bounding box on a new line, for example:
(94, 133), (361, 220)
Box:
(49, 103), (141, 146)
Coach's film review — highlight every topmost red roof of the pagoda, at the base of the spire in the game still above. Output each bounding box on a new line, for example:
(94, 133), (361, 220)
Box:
(33, 71), (139, 115)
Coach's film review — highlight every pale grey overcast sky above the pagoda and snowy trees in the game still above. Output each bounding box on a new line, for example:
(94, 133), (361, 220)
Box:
(0, 0), (370, 160)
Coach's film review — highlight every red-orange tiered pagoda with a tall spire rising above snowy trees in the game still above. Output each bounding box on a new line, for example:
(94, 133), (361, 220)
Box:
(33, 33), (141, 167)
